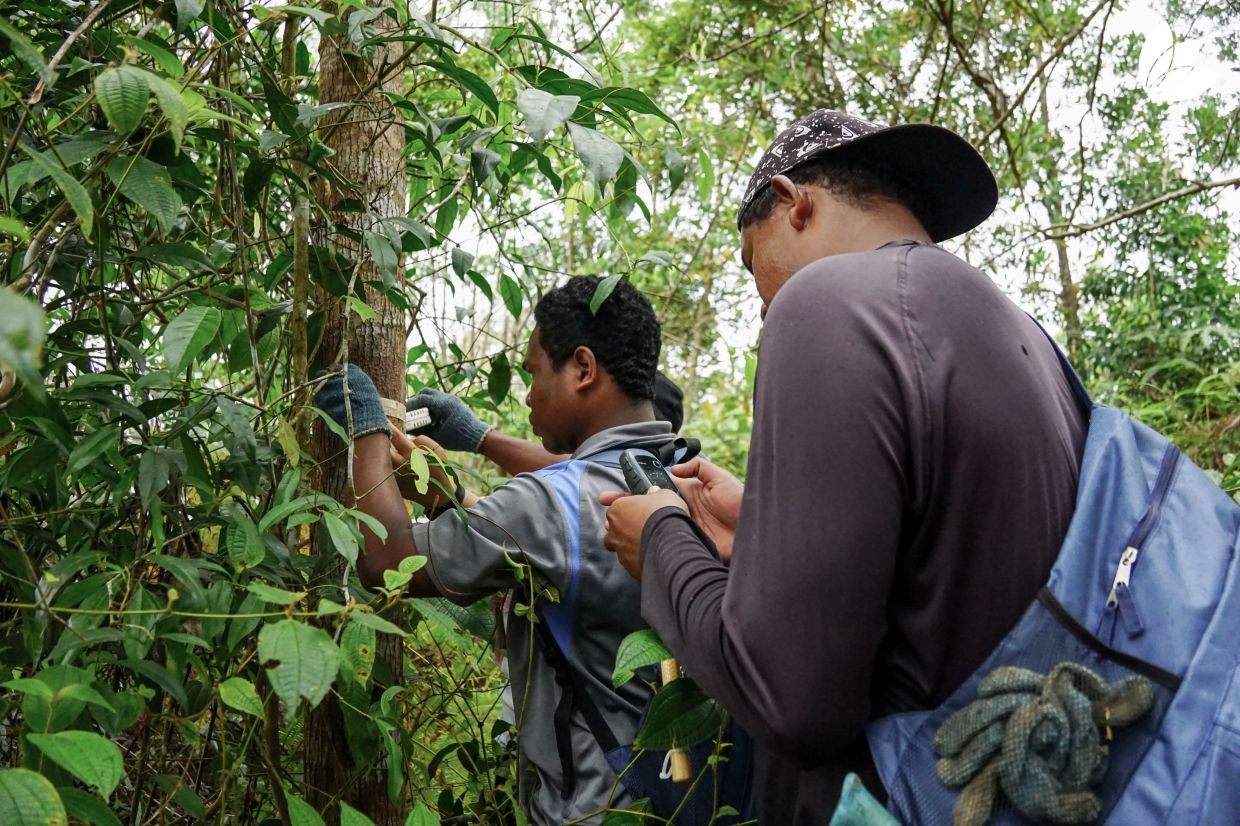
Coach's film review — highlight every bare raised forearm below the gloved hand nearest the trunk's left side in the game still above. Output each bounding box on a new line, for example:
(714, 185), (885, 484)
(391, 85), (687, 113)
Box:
(353, 433), (438, 597)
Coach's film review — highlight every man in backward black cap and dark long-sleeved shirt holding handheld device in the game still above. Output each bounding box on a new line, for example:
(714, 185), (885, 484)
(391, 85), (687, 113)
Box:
(604, 110), (1086, 826)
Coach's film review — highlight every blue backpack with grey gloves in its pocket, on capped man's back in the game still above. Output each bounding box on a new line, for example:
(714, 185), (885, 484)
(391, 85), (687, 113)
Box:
(863, 332), (1240, 826)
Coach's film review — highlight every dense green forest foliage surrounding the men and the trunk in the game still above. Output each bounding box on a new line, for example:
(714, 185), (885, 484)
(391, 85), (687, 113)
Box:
(0, 0), (1240, 825)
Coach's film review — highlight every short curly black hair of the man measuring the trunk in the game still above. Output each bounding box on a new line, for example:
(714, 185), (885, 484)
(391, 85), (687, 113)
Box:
(534, 275), (662, 401)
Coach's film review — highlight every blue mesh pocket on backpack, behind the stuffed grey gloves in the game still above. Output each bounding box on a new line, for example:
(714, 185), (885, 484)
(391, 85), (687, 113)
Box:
(888, 590), (1179, 826)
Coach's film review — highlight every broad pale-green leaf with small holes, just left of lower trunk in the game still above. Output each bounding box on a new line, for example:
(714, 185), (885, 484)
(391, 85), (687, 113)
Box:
(258, 619), (340, 718)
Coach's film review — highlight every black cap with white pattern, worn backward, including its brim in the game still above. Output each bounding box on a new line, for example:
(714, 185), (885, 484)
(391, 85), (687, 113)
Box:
(737, 109), (998, 243)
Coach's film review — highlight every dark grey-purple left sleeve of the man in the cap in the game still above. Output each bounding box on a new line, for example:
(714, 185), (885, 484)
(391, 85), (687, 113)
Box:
(642, 261), (923, 768)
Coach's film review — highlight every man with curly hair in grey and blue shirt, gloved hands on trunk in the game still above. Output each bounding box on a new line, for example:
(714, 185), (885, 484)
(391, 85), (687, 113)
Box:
(316, 277), (675, 825)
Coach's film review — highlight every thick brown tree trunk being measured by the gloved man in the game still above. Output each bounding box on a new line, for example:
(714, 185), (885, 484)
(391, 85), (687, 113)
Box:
(305, 1), (408, 826)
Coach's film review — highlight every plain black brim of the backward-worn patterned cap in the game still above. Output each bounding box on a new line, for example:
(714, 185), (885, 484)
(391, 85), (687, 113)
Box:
(816, 123), (999, 243)
